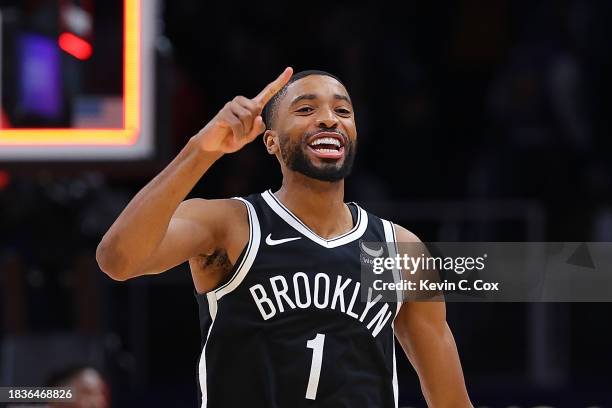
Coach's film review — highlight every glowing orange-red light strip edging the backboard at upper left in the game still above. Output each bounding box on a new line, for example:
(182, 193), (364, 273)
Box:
(0, 0), (143, 148)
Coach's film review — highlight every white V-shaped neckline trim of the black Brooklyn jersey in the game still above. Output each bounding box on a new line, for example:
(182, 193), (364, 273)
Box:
(261, 190), (368, 248)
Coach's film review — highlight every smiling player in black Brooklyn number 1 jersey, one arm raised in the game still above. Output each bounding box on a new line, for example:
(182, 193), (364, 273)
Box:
(96, 68), (472, 408)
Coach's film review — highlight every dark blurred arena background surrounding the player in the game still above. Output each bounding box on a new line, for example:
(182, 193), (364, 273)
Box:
(0, 0), (612, 407)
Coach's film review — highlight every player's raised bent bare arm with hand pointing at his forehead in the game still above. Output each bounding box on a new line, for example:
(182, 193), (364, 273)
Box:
(96, 68), (292, 280)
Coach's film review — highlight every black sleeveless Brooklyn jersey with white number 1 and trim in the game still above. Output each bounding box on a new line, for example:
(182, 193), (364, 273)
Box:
(196, 191), (400, 408)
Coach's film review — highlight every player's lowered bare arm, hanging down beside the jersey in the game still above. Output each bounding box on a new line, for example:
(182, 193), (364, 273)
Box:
(394, 225), (472, 408)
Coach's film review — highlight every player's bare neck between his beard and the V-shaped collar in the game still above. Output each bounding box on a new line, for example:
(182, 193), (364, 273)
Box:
(274, 171), (353, 238)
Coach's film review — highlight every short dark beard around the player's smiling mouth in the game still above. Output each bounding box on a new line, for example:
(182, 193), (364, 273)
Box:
(279, 131), (357, 182)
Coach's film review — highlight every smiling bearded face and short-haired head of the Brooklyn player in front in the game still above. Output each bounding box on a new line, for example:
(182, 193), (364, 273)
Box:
(266, 75), (357, 182)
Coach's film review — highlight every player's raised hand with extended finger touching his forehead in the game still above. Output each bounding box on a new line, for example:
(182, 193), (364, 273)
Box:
(195, 67), (293, 153)
